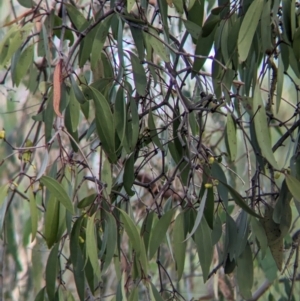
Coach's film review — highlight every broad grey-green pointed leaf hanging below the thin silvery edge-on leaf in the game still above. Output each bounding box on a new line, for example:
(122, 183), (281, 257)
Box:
(194, 218), (214, 282)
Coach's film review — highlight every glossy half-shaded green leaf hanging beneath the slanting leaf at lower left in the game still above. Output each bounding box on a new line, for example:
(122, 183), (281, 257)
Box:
(44, 195), (59, 249)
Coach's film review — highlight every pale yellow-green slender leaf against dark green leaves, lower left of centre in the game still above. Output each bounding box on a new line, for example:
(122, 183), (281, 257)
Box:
(85, 212), (100, 278)
